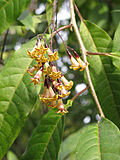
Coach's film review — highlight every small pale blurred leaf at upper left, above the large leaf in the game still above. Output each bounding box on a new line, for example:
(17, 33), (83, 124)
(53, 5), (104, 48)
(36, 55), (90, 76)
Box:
(17, 10), (35, 32)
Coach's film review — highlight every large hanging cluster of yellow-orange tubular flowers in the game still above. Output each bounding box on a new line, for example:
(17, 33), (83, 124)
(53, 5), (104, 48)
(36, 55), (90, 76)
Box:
(27, 38), (73, 114)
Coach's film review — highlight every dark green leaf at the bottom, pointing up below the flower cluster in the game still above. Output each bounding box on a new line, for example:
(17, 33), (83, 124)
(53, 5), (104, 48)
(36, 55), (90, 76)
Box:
(21, 110), (64, 160)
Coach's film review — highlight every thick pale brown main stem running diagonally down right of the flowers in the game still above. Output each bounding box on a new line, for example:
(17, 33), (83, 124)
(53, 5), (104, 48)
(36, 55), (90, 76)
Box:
(69, 0), (105, 117)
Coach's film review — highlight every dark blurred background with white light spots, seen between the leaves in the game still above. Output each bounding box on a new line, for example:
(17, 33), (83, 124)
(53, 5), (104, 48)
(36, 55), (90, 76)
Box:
(0, 0), (120, 159)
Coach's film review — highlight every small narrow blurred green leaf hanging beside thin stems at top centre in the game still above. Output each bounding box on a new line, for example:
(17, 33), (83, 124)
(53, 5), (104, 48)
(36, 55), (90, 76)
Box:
(46, 3), (53, 33)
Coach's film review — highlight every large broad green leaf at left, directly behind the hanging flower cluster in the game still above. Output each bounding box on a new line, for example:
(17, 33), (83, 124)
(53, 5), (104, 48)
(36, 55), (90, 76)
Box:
(0, 39), (39, 159)
